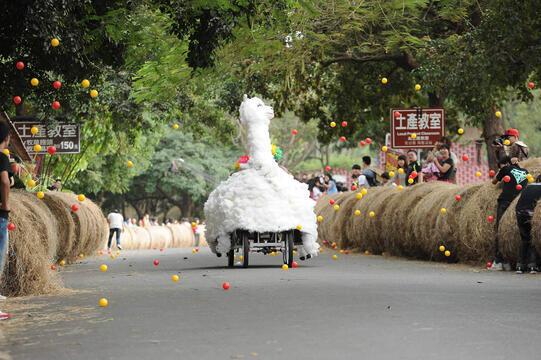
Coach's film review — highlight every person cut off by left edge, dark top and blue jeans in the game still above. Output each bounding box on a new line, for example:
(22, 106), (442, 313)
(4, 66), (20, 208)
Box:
(0, 122), (14, 320)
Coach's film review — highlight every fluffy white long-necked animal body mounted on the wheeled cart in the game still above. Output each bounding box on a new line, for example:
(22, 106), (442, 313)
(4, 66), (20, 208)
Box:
(205, 95), (319, 256)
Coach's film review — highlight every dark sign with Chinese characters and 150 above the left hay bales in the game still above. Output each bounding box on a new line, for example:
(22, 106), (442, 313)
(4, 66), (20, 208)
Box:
(14, 122), (81, 154)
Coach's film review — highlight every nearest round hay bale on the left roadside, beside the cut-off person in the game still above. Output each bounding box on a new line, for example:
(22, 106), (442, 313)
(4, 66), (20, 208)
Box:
(0, 190), (61, 296)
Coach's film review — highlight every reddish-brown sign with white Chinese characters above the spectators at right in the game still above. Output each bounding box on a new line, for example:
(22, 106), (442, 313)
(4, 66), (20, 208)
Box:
(390, 108), (445, 149)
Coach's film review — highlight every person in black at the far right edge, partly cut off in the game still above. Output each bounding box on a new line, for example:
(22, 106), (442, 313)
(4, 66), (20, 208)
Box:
(515, 175), (541, 274)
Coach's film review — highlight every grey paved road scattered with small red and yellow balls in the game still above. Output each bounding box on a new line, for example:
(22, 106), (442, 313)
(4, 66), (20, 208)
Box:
(0, 249), (541, 360)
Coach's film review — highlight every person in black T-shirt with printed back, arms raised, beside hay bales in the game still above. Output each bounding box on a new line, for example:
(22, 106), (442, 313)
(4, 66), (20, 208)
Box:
(490, 156), (528, 271)
